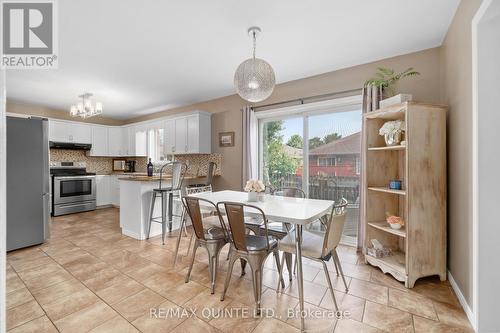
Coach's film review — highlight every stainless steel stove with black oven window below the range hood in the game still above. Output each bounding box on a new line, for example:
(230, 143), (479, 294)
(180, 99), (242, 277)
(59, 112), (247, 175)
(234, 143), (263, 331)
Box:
(50, 162), (96, 216)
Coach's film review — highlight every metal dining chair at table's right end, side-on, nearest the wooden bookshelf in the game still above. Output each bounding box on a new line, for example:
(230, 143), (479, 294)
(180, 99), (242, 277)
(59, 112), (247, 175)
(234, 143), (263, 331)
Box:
(276, 199), (349, 311)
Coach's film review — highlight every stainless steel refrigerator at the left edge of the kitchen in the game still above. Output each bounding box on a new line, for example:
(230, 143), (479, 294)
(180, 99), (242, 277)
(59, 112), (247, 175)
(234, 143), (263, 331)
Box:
(7, 117), (50, 251)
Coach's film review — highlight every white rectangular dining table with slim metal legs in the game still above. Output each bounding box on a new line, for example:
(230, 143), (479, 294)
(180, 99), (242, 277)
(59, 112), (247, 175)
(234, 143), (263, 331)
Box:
(184, 191), (333, 331)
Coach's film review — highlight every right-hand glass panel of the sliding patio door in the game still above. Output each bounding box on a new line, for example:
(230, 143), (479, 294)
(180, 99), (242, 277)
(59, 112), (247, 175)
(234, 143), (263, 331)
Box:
(308, 110), (361, 244)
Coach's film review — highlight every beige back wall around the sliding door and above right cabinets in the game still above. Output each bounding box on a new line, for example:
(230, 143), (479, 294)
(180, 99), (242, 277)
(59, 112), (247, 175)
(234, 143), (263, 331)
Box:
(127, 48), (440, 189)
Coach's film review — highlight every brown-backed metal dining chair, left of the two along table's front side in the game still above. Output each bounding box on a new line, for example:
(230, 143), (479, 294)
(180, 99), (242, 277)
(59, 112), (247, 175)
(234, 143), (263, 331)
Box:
(182, 197), (229, 294)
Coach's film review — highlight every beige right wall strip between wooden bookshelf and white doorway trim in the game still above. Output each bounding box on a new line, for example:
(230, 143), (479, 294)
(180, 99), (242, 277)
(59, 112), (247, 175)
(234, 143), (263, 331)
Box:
(440, 0), (481, 306)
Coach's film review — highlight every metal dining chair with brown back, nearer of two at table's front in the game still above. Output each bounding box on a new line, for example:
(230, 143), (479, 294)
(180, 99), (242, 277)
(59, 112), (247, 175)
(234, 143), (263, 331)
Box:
(217, 202), (285, 314)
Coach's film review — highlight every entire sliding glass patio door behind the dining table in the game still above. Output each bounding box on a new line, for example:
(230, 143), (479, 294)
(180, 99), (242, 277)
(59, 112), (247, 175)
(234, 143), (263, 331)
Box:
(257, 97), (362, 245)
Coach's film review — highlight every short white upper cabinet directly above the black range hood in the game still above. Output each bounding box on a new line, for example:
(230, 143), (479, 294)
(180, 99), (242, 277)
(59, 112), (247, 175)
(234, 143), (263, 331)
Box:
(49, 120), (92, 143)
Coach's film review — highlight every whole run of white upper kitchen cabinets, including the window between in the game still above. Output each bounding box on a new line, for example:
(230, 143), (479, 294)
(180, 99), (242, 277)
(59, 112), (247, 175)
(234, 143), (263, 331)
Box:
(49, 111), (212, 156)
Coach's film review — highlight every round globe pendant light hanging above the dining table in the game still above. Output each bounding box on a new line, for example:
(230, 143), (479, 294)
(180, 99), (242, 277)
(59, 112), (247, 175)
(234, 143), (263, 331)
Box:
(234, 27), (275, 103)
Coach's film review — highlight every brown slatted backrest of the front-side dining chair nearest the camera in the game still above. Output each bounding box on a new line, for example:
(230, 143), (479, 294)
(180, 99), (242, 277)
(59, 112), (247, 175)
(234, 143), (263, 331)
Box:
(217, 201), (270, 251)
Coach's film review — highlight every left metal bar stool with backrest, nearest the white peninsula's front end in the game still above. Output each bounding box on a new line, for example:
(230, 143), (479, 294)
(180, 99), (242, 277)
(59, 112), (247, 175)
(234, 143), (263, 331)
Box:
(146, 162), (187, 245)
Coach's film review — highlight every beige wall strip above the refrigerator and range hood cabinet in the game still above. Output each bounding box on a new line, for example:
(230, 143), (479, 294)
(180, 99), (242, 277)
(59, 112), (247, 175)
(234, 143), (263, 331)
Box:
(7, 100), (123, 126)
